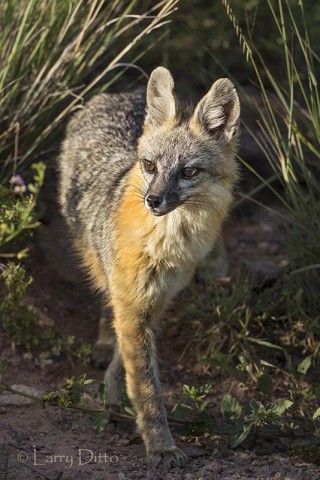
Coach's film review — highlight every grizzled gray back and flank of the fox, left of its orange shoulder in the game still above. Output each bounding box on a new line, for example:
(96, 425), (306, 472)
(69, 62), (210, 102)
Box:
(59, 93), (145, 282)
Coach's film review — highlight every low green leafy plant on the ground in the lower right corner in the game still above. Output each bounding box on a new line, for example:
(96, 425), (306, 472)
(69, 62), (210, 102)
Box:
(207, 352), (320, 448)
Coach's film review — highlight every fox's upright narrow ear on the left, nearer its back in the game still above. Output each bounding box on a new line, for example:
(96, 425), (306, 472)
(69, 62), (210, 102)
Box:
(145, 67), (176, 127)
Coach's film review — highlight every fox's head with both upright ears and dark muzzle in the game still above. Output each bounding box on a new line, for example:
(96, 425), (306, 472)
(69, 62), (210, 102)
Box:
(138, 67), (240, 216)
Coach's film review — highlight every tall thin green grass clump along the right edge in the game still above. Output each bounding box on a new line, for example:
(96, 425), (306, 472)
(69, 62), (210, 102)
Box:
(222, 0), (320, 321)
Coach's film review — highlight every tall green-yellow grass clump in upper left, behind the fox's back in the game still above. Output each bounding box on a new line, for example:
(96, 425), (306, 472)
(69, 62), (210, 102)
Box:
(0, 0), (178, 180)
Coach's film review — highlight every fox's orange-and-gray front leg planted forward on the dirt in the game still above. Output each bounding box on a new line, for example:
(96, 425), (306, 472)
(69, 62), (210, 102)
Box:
(114, 308), (186, 468)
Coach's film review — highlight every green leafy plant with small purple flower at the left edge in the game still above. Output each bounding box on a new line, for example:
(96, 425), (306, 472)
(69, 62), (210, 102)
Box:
(0, 162), (45, 350)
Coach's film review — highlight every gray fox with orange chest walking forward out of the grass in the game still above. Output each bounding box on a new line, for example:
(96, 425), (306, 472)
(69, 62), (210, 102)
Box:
(59, 67), (240, 468)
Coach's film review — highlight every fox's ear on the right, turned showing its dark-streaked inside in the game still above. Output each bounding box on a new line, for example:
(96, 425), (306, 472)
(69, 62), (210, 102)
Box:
(191, 78), (240, 141)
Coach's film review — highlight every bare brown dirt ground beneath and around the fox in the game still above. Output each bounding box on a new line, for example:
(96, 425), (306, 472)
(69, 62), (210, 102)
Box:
(0, 171), (320, 480)
